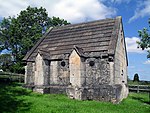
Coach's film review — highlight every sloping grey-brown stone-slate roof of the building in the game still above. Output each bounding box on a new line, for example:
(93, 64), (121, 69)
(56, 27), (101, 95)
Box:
(23, 17), (121, 61)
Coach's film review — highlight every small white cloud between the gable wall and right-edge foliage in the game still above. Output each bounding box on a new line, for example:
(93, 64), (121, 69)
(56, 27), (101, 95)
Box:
(125, 37), (146, 53)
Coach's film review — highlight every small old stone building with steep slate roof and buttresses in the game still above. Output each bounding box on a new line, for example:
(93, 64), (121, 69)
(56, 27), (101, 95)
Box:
(23, 17), (128, 102)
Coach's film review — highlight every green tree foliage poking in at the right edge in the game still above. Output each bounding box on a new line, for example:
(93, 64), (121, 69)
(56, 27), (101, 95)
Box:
(137, 19), (150, 58)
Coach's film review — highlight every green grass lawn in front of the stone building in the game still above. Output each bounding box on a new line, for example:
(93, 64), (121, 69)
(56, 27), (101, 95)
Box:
(0, 82), (150, 113)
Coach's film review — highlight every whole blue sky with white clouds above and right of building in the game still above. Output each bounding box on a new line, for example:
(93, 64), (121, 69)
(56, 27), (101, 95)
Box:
(0, 0), (150, 81)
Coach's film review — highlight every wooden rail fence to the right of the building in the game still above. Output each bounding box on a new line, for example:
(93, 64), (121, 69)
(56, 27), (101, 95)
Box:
(129, 85), (150, 93)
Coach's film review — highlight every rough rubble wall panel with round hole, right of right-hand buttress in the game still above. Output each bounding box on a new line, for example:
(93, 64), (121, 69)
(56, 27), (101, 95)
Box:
(85, 58), (111, 87)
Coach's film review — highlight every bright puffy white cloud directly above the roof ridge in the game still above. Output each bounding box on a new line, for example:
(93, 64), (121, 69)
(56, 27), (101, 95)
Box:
(51, 0), (116, 23)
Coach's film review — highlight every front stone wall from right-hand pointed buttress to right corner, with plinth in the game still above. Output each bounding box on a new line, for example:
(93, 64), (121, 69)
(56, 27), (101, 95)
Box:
(67, 51), (123, 103)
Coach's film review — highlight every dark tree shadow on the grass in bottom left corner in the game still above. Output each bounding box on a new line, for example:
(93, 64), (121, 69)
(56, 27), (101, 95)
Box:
(0, 80), (31, 113)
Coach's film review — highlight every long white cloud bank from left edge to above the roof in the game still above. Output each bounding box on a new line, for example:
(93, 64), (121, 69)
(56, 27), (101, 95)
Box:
(0, 0), (116, 23)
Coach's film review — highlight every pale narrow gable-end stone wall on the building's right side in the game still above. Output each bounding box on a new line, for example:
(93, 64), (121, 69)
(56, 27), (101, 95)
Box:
(114, 24), (128, 99)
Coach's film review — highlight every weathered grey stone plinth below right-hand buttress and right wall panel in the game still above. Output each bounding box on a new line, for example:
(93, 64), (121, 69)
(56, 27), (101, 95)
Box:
(67, 85), (122, 103)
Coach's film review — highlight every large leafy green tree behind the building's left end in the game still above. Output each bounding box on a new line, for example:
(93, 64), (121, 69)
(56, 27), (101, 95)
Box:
(0, 6), (70, 73)
